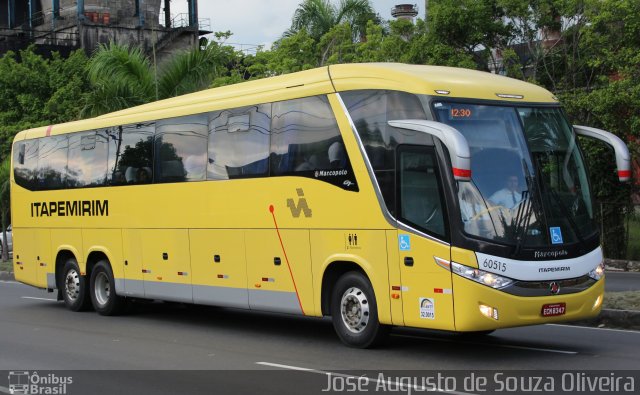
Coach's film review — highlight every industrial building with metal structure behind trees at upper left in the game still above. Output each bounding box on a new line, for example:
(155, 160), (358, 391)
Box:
(0, 0), (210, 61)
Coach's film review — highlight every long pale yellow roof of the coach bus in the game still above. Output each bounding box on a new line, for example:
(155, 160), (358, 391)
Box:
(15, 63), (557, 140)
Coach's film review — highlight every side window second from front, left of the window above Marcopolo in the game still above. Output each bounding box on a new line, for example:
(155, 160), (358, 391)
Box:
(207, 104), (271, 180)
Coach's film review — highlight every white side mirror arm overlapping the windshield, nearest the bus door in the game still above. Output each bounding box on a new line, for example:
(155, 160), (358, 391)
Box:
(388, 119), (471, 181)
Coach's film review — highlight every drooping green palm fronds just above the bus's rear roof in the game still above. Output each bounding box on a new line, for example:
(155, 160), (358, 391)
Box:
(82, 42), (229, 116)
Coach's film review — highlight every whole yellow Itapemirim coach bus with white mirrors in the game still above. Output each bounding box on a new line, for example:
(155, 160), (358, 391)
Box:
(11, 63), (630, 347)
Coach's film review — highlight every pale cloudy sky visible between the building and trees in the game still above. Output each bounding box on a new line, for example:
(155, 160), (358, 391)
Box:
(171, 0), (424, 49)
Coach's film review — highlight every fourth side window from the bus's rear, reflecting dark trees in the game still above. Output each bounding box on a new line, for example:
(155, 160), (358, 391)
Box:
(108, 122), (155, 185)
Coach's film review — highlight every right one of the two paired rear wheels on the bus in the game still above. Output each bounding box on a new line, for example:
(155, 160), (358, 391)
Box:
(90, 260), (125, 315)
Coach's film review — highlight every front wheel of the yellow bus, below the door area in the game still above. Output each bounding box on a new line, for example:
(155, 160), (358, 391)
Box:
(331, 271), (389, 348)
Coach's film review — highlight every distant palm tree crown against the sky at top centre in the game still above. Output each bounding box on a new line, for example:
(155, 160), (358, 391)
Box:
(284, 0), (380, 40)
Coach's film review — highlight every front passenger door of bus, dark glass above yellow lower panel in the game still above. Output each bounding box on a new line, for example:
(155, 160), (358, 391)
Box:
(397, 146), (454, 330)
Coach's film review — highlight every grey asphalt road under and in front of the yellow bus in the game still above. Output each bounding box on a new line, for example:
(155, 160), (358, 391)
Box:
(0, 282), (640, 395)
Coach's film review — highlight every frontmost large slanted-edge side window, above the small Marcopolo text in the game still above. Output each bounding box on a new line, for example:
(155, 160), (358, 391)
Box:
(271, 96), (348, 175)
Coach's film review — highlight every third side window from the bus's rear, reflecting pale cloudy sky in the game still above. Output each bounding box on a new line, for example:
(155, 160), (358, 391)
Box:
(67, 131), (109, 188)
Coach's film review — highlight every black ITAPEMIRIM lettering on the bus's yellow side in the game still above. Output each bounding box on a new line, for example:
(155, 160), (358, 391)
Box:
(31, 200), (109, 217)
